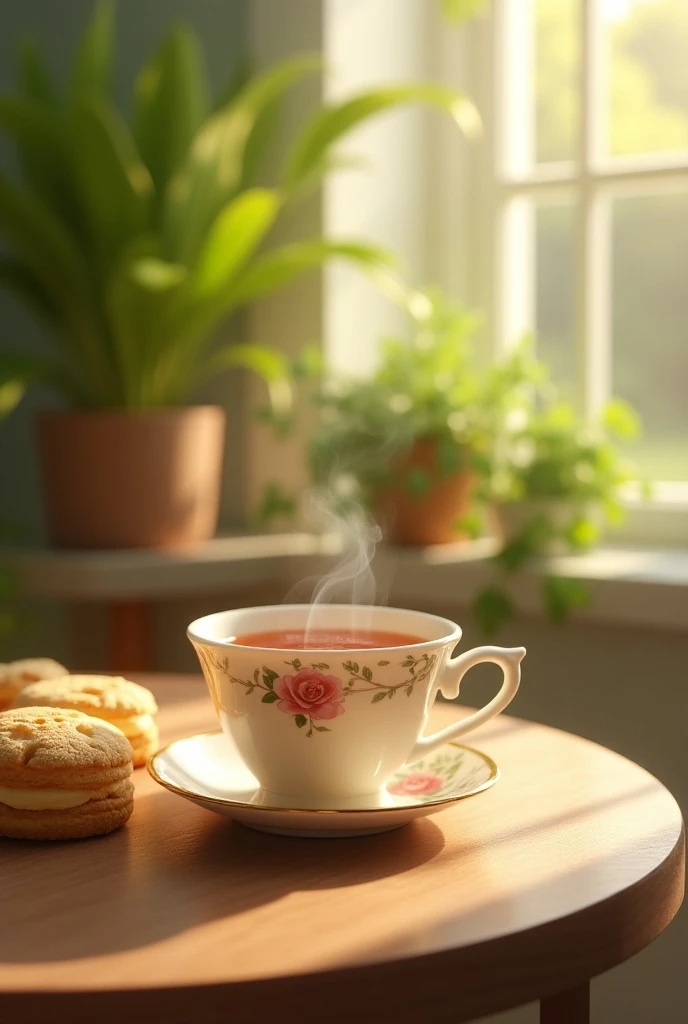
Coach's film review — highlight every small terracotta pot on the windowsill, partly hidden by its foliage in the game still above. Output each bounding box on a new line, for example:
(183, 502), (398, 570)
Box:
(375, 438), (476, 546)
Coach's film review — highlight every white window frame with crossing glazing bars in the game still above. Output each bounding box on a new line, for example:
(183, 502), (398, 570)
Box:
(432, 0), (688, 545)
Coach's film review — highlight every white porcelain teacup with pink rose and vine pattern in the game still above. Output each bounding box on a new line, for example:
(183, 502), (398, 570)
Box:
(187, 604), (525, 804)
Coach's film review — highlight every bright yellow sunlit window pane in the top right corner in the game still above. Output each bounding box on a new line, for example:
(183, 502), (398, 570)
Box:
(602, 0), (688, 156)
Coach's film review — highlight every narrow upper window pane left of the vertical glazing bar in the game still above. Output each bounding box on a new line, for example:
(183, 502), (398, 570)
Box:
(534, 0), (579, 163)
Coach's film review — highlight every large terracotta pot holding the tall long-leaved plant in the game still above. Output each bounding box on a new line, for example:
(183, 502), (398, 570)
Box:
(39, 406), (225, 549)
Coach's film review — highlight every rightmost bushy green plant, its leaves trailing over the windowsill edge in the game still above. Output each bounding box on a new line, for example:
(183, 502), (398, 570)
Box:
(475, 391), (640, 634)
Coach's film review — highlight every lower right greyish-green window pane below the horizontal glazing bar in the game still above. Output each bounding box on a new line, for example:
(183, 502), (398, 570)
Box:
(612, 194), (688, 480)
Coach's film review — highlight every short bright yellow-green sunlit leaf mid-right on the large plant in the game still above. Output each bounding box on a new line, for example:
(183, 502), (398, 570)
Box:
(192, 188), (280, 299)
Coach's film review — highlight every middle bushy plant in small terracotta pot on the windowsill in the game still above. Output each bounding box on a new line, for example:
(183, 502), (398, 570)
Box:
(298, 292), (534, 545)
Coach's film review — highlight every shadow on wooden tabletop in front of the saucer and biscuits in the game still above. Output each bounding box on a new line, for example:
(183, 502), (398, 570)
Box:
(0, 790), (444, 965)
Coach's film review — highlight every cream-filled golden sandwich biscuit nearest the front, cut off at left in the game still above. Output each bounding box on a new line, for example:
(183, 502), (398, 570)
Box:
(0, 708), (134, 840)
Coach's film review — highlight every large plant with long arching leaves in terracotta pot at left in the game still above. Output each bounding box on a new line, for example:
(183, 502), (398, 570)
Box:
(0, 3), (477, 547)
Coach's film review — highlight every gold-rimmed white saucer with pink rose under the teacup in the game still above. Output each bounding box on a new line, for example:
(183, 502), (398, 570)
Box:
(148, 731), (500, 838)
